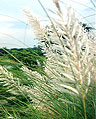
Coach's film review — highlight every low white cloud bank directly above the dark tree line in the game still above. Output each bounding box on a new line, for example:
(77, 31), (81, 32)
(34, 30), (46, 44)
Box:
(0, 23), (37, 48)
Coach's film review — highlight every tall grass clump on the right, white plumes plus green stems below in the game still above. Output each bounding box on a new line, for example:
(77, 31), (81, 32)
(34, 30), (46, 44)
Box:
(25, 0), (96, 119)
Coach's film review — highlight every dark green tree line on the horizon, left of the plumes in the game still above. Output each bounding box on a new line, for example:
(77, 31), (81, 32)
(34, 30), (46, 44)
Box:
(0, 46), (46, 70)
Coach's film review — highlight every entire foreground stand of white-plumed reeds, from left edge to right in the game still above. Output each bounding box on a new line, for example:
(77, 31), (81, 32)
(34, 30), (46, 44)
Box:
(0, 0), (96, 119)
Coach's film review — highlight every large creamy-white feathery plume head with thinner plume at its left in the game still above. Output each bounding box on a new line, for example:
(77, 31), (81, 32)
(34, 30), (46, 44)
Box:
(26, 4), (96, 107)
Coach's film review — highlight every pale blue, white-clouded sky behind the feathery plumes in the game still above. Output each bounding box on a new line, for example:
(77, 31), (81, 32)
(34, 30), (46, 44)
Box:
(0, 0), (95, 48)
